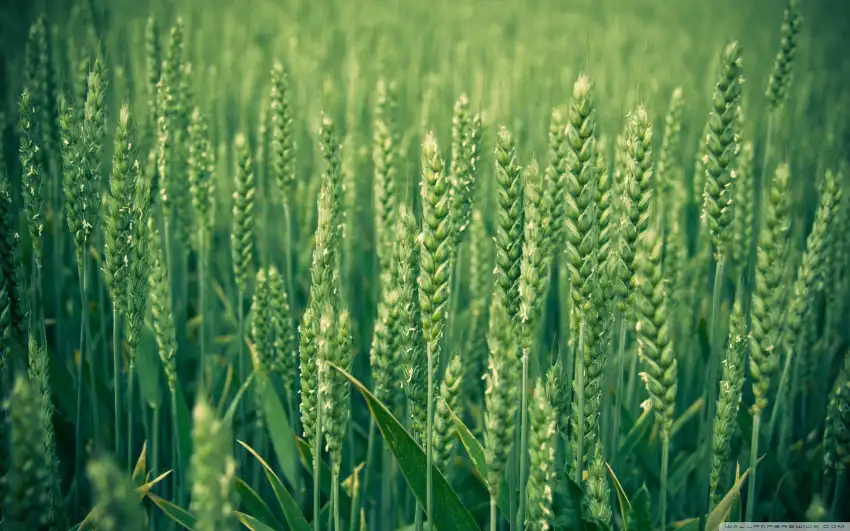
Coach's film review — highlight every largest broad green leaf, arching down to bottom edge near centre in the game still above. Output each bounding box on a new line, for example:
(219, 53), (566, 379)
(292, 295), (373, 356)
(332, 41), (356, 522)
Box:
(330, 364), (478, 531)
